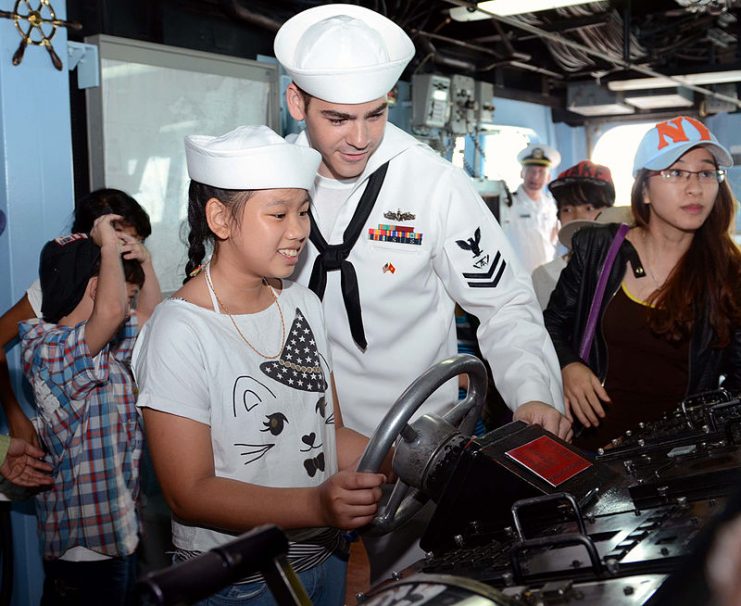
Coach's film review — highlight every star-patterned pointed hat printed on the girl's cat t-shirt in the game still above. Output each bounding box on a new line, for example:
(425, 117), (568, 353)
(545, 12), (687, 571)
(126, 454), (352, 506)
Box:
(260, 308), (327, 392)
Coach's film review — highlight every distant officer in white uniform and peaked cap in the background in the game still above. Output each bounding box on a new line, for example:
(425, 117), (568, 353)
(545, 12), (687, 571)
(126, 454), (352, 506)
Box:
(500, 143), (561, 272)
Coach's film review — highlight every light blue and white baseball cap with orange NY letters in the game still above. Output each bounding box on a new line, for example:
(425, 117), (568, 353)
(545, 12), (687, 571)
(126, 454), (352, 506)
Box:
(633, 116), (733, 177)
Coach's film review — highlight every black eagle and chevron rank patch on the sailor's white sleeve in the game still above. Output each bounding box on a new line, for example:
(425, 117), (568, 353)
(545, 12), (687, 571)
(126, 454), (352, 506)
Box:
(445, 227), (507, 288)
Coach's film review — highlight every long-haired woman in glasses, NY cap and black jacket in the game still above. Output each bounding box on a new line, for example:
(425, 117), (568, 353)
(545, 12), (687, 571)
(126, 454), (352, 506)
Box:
(545, 116), (741, 450)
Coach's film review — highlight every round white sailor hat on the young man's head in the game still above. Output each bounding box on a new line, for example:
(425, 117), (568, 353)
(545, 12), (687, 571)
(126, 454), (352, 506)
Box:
(273, 4), (414, 104)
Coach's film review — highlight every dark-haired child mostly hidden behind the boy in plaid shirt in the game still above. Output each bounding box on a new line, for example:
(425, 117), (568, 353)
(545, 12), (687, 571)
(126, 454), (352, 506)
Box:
(0, 189), (162, 446)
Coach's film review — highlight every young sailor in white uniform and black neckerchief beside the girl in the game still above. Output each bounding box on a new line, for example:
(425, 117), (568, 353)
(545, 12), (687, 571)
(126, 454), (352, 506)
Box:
(274, 4), (571, 580)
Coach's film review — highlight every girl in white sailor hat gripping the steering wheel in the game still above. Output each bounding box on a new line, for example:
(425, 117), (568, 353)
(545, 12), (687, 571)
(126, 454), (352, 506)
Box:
(134, 126), (384, 604)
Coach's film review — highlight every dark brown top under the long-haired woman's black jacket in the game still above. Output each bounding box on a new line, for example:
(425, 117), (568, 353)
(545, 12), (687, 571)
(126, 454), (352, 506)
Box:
(574, 285), (689, 451)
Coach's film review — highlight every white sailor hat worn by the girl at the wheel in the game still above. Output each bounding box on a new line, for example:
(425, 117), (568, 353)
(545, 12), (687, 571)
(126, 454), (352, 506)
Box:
(185, 126), (322, 189)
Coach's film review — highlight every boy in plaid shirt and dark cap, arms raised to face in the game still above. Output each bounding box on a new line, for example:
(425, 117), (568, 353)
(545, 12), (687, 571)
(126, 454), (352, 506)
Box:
(20, 215), (148, 606)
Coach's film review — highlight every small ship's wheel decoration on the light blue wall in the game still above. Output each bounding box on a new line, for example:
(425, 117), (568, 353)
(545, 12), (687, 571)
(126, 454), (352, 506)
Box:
(0, 0), (82, 71)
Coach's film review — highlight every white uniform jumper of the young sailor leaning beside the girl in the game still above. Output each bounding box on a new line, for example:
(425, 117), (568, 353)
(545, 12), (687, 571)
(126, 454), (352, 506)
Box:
(293, 124), (563, 435)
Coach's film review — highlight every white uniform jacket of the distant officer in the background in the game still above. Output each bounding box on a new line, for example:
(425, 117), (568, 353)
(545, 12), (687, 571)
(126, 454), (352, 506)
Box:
(499, 185), (558, 272)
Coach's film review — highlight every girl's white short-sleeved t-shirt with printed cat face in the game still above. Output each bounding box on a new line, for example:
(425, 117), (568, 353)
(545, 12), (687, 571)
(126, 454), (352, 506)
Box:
(132, 281), (337, 551)
